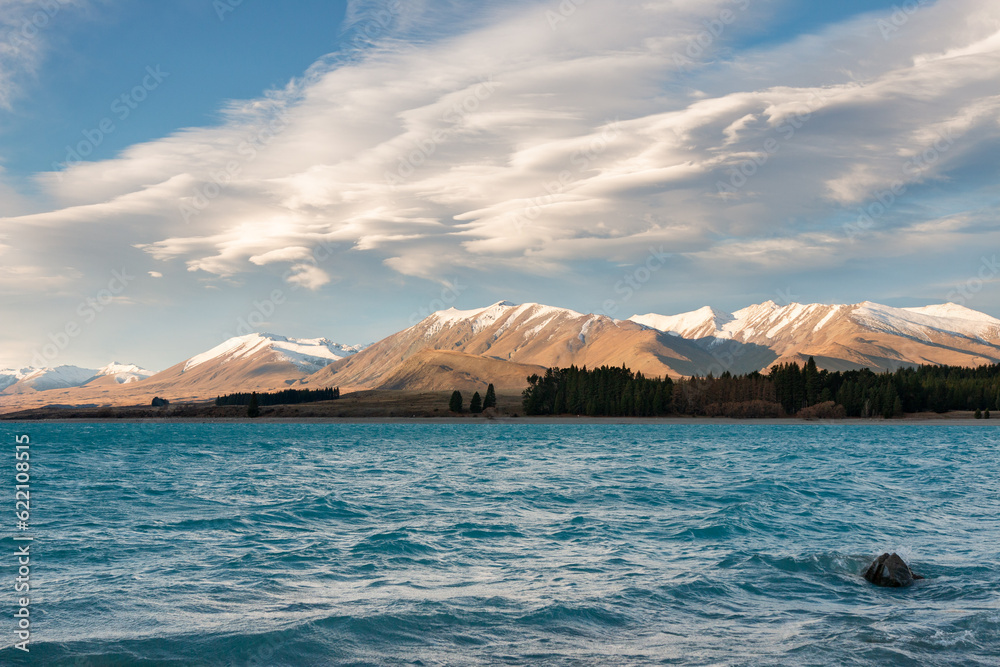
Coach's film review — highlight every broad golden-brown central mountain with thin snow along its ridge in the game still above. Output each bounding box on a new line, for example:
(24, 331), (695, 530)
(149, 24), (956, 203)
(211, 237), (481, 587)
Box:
(305, 301), (740, 390)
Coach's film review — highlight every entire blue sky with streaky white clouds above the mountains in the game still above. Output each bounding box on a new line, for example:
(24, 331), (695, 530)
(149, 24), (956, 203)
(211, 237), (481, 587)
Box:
(0, 0), (1000, 370)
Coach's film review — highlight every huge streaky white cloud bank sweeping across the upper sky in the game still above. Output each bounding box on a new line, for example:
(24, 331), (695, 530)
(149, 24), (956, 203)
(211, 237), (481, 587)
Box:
(0, 0), (1000, 300)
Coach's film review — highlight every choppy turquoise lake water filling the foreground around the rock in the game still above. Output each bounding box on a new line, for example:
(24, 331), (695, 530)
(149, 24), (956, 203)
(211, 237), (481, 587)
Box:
(0, 424), (1000, 666)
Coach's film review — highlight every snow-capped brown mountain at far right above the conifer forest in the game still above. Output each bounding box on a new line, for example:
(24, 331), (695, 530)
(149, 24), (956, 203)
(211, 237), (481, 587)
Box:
(630, 301), (1000, 371)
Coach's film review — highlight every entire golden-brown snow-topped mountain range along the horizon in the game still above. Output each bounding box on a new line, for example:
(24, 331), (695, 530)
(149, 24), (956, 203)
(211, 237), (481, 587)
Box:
(0, 301), (1000, 412)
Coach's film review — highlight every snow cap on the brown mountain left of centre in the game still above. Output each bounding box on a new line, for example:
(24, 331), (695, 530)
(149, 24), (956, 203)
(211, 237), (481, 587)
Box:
(184, 333), (364, 372)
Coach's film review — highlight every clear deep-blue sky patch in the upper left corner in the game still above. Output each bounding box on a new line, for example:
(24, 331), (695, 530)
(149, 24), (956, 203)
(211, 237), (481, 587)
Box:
(2, 0), (346, 179)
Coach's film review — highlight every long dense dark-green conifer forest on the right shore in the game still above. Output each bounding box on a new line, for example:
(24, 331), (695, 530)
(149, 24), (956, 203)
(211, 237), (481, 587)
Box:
(522, 357), (1000, 418)
